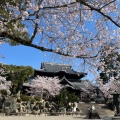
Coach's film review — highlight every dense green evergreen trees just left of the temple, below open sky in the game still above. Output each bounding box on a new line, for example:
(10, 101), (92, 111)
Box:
(0, 64), (34, 95)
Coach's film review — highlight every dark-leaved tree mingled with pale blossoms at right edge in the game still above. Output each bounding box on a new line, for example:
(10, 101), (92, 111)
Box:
(98, 45), (120, 83)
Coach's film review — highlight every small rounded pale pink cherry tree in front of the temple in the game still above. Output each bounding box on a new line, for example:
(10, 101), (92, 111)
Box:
(28, 76), (62, 98)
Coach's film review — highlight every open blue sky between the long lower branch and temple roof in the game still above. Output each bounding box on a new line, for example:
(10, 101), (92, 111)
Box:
(0, 44), (94, 80)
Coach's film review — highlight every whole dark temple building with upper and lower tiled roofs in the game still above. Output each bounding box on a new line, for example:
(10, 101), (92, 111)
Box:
(24, 62), (95, 100)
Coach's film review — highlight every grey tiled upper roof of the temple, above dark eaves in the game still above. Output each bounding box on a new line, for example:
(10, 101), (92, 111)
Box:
(41, 63), (86, 75)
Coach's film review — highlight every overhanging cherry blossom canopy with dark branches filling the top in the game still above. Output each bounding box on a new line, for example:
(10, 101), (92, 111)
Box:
(0, 0), (120, 70)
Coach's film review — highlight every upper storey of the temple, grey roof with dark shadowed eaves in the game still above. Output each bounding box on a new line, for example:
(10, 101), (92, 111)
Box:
(35, 63), (87, 80)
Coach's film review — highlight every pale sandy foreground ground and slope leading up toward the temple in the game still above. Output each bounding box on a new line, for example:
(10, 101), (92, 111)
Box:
(0, 103), (114, 120)
